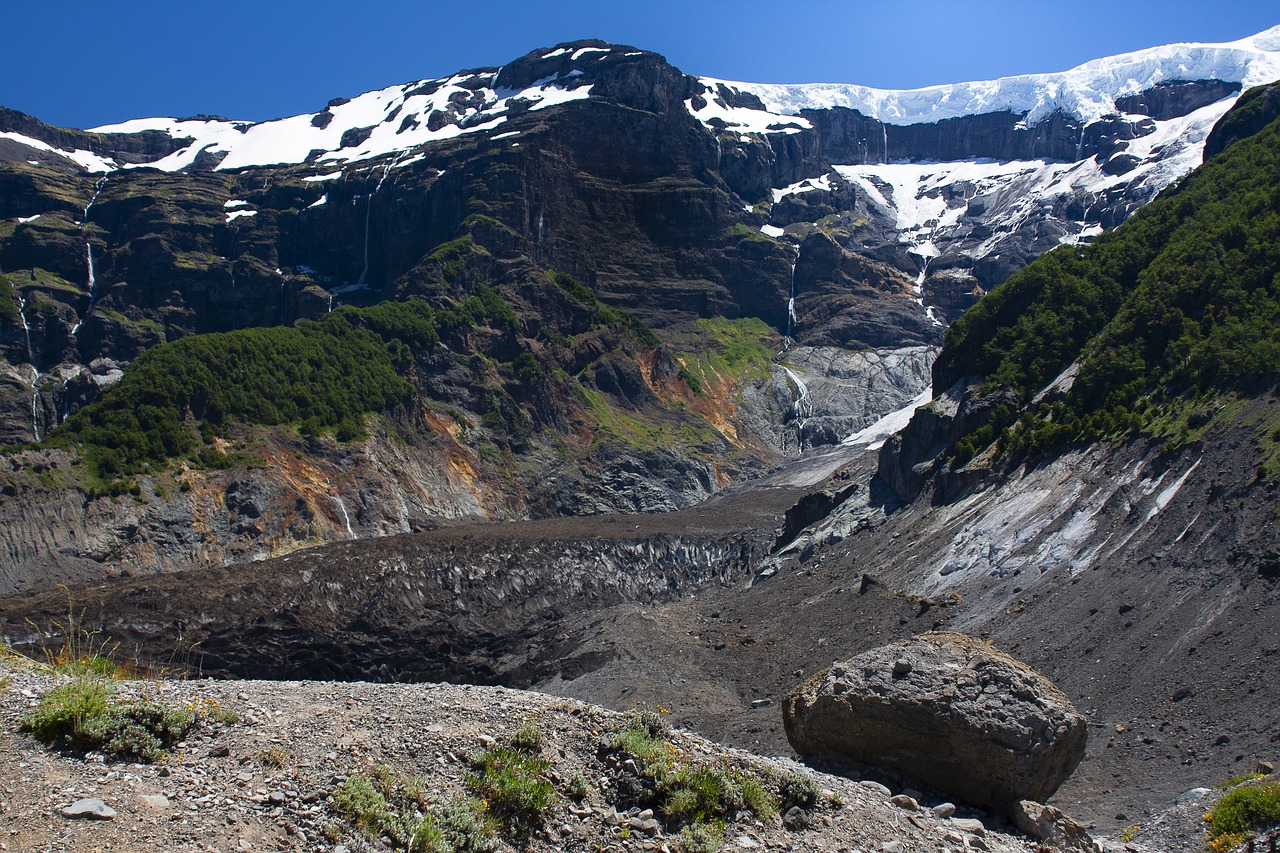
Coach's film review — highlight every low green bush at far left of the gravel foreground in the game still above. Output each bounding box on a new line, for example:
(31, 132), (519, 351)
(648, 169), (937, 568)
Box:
(18, 678), (195, 761)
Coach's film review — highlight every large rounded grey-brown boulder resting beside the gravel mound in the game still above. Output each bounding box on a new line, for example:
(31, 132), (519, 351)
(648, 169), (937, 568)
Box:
(783, 633), (1087, 809)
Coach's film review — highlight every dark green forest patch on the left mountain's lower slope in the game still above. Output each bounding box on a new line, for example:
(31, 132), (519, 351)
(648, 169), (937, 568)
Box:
(46, 287), (516, 483)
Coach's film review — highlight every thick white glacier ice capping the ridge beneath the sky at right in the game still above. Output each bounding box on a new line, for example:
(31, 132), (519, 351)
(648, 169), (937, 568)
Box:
(701, 26), (1280, 124)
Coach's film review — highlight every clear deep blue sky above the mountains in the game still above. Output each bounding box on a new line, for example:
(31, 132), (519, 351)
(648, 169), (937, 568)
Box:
(10, 0), (1280, 127)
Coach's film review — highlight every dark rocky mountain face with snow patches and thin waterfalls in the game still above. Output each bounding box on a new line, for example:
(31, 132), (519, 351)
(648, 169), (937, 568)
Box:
(0, 28), (1262, 584)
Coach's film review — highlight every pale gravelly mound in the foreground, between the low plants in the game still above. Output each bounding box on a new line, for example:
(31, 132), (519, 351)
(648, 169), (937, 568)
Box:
(0, 665), (1070, 853)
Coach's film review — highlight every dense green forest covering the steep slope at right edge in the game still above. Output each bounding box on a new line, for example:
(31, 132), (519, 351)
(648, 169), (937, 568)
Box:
(934, 81), (1280, 461)
